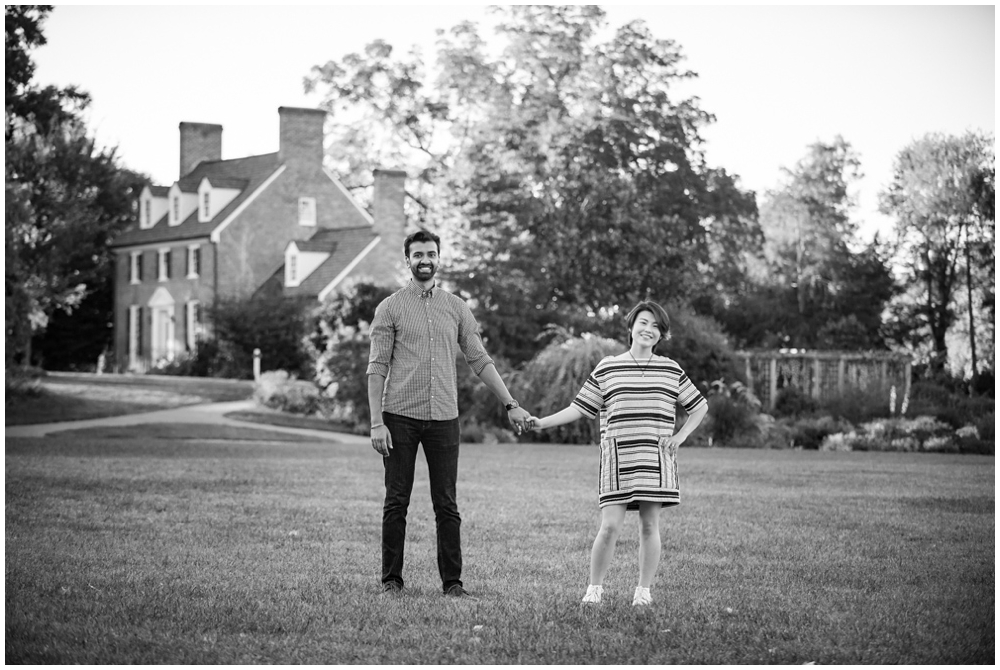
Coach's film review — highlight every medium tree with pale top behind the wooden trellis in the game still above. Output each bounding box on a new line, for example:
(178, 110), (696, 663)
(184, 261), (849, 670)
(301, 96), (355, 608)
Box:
(725, 136), (894, 349)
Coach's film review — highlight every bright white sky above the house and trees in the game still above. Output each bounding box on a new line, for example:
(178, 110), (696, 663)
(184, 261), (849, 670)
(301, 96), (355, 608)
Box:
(33, 4), (995, 242)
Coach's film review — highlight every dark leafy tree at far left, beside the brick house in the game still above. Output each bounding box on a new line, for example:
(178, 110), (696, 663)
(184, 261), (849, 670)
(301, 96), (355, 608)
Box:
(4, 6), (147, 366)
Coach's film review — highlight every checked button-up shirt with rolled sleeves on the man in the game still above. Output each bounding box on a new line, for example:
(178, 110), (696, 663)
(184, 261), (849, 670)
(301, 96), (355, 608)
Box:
(367, 279), (493, 421)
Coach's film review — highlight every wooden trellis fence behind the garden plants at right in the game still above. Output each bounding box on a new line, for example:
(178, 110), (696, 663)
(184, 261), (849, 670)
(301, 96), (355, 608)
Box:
(737, 350), (912, 409)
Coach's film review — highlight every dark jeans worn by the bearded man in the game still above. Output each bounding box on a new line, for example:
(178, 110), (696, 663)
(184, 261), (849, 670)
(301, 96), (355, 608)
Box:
(382, 412), (462, 590)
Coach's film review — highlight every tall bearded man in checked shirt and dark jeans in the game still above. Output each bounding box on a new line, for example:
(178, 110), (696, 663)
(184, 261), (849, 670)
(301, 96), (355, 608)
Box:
(367, 230), (530, 598)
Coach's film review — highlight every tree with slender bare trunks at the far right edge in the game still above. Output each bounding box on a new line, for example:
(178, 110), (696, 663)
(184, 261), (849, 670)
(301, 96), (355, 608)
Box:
(881, 132), (996, 375)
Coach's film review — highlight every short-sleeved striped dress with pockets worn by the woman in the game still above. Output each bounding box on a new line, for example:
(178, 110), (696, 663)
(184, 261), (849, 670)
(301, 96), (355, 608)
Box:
(573, 355), (706, 510)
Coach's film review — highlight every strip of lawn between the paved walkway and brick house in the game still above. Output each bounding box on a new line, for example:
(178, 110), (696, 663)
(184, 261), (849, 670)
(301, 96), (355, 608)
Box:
(4, 372), (253, 426)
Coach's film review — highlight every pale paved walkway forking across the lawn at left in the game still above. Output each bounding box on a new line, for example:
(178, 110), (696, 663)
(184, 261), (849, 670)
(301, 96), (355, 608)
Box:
(4, 400), (369, 445)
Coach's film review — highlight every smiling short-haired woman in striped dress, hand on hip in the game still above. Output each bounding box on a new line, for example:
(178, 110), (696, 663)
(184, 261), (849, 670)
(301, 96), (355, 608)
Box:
(529, 300), (708, 605)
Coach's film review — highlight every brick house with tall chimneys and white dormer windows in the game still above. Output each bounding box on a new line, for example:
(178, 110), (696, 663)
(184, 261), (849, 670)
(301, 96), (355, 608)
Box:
(112, 107), (406, 371)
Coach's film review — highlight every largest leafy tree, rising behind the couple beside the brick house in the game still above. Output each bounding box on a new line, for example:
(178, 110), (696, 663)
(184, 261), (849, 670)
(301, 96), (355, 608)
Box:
(309, 6), (759, 363)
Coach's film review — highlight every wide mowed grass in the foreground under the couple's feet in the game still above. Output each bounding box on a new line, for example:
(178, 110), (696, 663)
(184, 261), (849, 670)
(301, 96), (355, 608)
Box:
(5, 426), (995, 664)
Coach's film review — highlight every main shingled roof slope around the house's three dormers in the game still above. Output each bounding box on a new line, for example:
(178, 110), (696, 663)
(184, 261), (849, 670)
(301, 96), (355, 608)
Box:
(111, 153), (280, 247)
